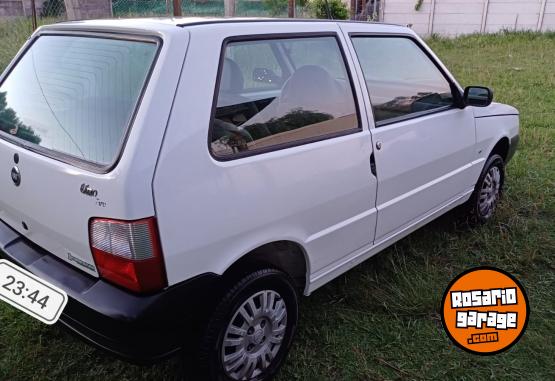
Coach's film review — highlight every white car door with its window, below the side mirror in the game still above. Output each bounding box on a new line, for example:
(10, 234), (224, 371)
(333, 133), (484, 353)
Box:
(347, 26), (475, 244)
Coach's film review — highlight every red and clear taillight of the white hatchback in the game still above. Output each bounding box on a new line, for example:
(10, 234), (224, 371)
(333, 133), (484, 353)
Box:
(89, 217), (167, 293)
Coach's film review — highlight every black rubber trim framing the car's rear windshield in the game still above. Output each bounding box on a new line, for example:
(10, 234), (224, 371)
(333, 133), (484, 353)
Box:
(0, 30), (164, 174)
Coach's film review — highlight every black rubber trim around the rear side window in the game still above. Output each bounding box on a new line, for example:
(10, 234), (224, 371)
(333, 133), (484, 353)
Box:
(207, 31), (362, 162)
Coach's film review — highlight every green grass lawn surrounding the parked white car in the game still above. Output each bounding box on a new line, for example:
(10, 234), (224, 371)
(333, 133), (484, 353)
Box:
(0, 33), (555, 381)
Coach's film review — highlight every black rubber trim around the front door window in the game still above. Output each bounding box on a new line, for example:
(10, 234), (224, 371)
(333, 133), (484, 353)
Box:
(348, 32), (463, 128)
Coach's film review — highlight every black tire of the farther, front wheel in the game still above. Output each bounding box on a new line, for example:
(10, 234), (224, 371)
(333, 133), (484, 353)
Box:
(466, 154), (505, 224)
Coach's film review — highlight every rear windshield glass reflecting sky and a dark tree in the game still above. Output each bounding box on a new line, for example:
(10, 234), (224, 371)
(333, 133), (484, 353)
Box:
(0, 36), (157, 167)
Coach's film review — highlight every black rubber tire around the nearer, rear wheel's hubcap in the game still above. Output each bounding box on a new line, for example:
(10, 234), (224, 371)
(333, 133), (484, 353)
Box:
(197, 269), (298, 381)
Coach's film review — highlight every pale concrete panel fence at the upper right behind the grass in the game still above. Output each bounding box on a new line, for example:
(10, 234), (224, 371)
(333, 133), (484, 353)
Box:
(381, 0), (555, 36)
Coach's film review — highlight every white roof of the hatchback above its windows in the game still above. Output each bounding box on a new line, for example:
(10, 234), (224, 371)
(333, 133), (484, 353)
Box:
(41, 17), (408, 33)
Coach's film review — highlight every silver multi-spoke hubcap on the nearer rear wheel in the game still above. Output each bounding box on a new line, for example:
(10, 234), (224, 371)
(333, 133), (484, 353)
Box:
(222, 290), (287, 380)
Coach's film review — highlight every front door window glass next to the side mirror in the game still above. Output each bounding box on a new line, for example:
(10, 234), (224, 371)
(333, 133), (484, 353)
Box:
(353, 37), (453, 126)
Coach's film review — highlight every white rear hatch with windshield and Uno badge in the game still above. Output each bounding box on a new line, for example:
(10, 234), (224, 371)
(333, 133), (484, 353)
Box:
(0, 33), (160, 276)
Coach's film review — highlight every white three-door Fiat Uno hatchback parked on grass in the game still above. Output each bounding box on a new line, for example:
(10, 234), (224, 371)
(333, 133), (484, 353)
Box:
(0, 18), (519, 380)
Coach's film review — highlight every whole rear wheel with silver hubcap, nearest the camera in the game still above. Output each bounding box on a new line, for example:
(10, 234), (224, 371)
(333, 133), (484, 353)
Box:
(199, 269), (298, 381)
